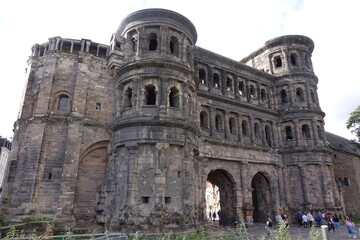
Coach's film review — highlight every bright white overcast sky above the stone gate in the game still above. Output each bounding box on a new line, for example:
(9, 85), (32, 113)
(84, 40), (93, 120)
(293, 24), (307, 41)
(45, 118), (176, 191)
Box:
(0, 0), (360, 139)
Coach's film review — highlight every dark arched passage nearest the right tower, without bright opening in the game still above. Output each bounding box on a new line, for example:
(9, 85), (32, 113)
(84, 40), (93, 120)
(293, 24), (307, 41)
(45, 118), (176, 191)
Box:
(251, 173), (272, 223)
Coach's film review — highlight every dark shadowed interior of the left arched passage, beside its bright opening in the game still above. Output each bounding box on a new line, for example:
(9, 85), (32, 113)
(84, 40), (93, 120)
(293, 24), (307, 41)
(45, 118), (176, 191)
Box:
(207, 169), (236, 226)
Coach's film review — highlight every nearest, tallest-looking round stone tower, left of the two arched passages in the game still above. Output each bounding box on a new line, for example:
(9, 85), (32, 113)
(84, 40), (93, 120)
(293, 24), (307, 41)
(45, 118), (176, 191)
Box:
(98, 9), (199, 233)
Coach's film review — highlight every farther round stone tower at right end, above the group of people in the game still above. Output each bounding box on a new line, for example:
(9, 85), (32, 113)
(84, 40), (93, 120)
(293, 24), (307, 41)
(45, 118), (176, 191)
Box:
(242, 35), (340, 214)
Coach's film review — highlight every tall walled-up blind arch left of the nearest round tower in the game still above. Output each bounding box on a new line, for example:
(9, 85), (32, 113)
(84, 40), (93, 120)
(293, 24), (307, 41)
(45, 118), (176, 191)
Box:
(73, 140), (110, 226)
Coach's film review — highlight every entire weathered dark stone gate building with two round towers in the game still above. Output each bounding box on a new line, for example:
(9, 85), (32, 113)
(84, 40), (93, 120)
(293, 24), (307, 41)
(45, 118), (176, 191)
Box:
(1, 9), (342, 232)
